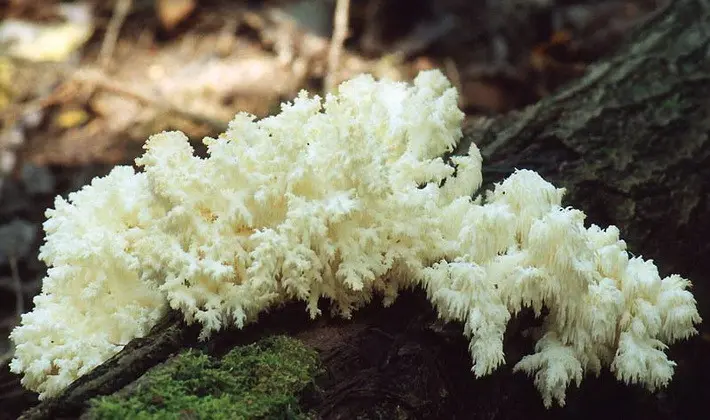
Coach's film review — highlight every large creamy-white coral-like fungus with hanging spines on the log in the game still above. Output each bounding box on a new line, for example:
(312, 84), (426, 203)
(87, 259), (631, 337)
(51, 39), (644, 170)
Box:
(11, 71), (700, 406)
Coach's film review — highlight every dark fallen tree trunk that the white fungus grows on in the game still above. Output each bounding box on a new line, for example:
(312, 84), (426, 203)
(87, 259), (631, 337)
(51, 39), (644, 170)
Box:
(6, 0), (710, 419)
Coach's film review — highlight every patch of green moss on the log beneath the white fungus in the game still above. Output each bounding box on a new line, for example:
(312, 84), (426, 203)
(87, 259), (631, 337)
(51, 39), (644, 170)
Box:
(84, 336), (326, 419)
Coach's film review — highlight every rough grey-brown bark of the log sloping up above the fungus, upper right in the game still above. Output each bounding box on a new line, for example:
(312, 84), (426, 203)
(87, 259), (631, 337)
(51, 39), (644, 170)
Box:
(462, 0), (710, 288)
